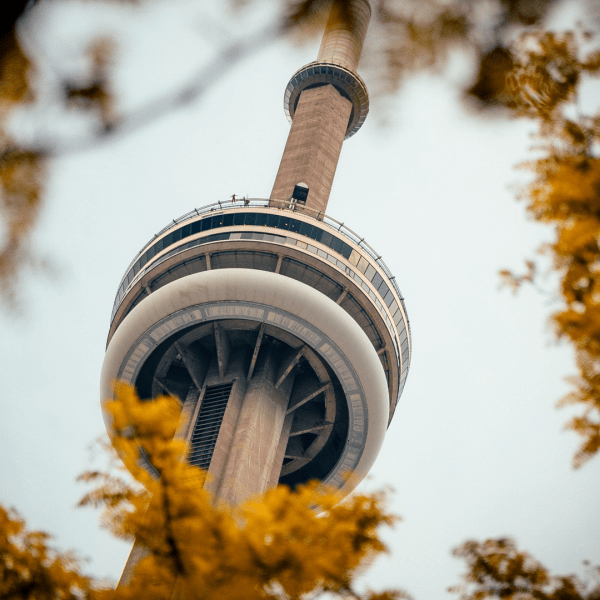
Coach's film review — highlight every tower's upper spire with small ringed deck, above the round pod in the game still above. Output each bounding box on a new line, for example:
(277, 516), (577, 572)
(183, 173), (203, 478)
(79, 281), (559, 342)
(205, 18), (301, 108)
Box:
(271, 0), (371, 213)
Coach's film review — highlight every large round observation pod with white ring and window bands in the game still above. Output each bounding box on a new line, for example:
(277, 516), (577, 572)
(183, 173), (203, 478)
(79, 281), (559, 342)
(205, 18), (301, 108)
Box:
(103, 198), (411, 502)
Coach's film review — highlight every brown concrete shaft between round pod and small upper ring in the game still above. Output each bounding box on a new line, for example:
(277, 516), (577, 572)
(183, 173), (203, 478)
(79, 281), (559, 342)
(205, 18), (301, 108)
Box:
(271, 84), (352, 212)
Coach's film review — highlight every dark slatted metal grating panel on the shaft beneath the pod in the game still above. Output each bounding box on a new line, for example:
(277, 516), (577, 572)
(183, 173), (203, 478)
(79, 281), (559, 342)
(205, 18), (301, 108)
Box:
(188, 382), (233, 471)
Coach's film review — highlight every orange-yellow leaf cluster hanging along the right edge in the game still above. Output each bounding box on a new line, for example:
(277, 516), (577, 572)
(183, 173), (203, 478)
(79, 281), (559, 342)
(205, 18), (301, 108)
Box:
(501, 32), (600, 467)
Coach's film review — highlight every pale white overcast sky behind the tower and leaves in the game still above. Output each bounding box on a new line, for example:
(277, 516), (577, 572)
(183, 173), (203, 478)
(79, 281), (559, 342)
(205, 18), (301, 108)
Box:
(0, 1), (600, 600)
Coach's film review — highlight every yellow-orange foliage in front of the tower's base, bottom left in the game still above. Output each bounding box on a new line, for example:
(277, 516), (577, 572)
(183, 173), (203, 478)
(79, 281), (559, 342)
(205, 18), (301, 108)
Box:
(0, 385), (406, 600)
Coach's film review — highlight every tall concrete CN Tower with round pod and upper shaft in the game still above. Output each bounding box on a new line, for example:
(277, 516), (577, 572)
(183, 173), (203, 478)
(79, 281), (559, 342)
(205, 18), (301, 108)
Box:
(101, 0), (411, 524)
